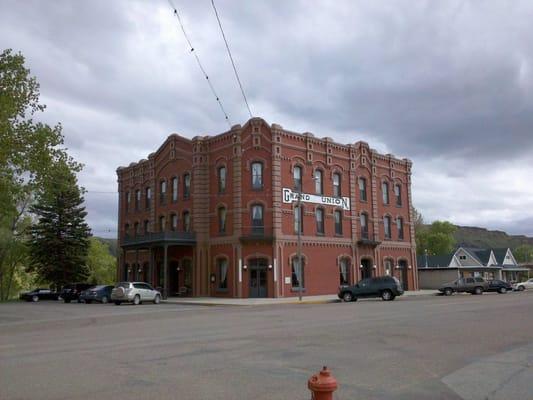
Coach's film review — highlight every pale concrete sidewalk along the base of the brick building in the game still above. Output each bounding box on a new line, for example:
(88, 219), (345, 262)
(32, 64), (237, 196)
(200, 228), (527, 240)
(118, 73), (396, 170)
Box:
(163, 290), (437, 306)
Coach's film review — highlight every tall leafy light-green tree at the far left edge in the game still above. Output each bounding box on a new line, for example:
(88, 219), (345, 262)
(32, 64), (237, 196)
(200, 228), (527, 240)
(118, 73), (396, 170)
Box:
(0, 49), (81, 299)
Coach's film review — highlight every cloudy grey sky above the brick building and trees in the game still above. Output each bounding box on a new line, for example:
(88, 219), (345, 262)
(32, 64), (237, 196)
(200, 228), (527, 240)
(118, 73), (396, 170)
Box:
(0, 0), (533, 236)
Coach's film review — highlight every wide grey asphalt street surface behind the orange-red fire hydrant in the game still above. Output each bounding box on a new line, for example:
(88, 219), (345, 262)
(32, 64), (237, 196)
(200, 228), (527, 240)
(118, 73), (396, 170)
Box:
(0, 292), (533, 400)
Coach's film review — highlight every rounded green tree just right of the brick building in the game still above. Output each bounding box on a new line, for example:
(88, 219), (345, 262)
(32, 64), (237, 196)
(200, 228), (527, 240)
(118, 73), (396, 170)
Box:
(416, 221), (457, 255)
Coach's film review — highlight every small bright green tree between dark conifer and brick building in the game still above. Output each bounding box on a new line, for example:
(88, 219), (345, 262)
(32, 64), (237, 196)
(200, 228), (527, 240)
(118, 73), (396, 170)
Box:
(87, 237), (117, 284)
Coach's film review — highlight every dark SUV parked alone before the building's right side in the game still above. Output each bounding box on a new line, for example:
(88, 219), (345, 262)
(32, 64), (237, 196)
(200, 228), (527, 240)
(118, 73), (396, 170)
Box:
(338, 276), (403, 301)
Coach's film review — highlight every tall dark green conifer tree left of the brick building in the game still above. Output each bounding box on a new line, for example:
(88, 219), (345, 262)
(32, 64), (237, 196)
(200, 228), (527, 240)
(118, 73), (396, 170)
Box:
(28, 164), (90, 288)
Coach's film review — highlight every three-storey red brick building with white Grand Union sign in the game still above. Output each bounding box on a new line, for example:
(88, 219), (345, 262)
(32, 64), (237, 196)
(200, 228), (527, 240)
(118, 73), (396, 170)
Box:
(117, 118), (418, 297)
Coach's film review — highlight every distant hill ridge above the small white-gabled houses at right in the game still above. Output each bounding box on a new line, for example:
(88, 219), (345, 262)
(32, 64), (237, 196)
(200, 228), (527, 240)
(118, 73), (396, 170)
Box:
(455, 226), (533, 249)
